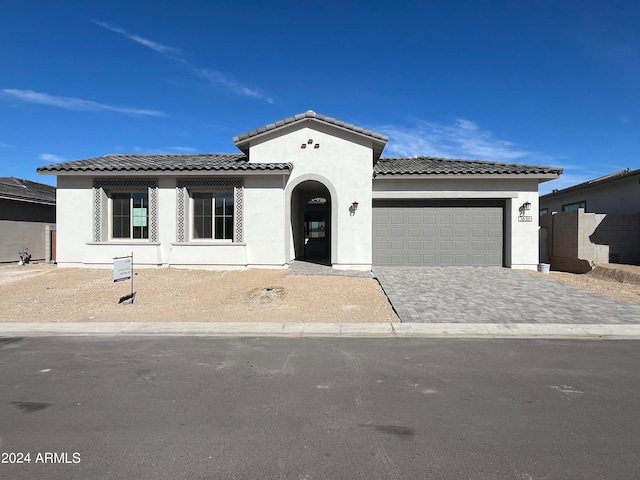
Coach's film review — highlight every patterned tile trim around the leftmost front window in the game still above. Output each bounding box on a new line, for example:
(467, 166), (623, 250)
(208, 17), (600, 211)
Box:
(93, 179), (158, 242)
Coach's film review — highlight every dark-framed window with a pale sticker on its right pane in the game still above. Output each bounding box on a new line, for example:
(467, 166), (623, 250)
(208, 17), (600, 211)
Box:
(110, 192), (149, 239)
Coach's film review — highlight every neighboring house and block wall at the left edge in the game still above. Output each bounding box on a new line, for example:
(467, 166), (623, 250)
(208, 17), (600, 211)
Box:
(0, 177), (56, 263)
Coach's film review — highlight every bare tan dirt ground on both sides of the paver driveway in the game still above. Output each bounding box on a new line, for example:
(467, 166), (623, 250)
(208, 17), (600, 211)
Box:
(0, 264), (640, 323)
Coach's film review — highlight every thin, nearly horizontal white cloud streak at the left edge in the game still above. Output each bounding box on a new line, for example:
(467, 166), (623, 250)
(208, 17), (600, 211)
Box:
(0, 88), (167, 117)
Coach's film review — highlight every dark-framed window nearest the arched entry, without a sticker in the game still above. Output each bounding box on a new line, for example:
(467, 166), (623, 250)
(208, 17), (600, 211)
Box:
(191, 190), (234, 240)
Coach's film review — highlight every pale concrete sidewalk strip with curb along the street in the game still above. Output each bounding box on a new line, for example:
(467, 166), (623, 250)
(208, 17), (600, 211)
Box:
(0, 322), (640, 340)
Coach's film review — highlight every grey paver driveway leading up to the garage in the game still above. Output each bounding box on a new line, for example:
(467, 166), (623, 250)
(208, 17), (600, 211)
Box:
(373, 267), (640, 324)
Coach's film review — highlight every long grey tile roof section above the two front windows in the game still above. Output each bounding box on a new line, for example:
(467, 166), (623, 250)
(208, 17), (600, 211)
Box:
(38, 153), (293, 174)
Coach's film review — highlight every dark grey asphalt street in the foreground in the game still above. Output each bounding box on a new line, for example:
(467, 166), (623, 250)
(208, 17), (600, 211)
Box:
(0, 337), (640, 480)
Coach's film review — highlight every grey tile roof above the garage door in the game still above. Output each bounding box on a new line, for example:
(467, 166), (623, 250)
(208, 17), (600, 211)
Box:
(373, 157), (562, 177)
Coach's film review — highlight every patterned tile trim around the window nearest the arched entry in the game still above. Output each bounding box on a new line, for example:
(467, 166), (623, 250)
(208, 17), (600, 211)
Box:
(176, 178), (244, 243)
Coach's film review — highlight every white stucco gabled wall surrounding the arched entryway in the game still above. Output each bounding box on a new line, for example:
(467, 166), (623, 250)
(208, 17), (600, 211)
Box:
(249, 121), (373, 269)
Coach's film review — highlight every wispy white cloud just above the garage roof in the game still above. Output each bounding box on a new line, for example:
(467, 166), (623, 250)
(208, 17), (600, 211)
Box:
(376, 118), (533, 162)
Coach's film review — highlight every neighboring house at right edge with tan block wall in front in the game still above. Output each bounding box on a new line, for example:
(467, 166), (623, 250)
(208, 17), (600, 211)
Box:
(540, 168), (640, 273)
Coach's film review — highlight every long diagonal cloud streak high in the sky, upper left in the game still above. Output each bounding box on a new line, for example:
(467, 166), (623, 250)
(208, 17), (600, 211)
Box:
(93, 20), (274, 103)
